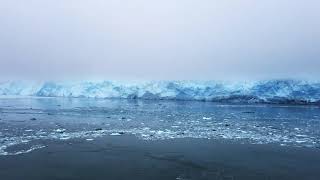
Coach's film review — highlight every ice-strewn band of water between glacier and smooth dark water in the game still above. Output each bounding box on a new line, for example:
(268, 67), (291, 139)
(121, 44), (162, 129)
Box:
(0, 97), (320, 156)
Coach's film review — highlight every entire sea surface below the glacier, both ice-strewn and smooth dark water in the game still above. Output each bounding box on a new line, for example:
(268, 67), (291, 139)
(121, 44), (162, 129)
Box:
(0, 98), (320, 179)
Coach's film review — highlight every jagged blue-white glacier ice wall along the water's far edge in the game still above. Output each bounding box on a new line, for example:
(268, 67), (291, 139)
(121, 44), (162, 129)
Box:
(0, 80), (320, 104)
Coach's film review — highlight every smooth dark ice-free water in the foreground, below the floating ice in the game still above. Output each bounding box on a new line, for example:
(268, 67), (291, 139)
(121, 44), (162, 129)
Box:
(0, 135), (320, 180)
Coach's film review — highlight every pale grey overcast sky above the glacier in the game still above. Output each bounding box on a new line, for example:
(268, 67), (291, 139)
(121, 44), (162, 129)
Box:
(0, 0), (320, 80)
